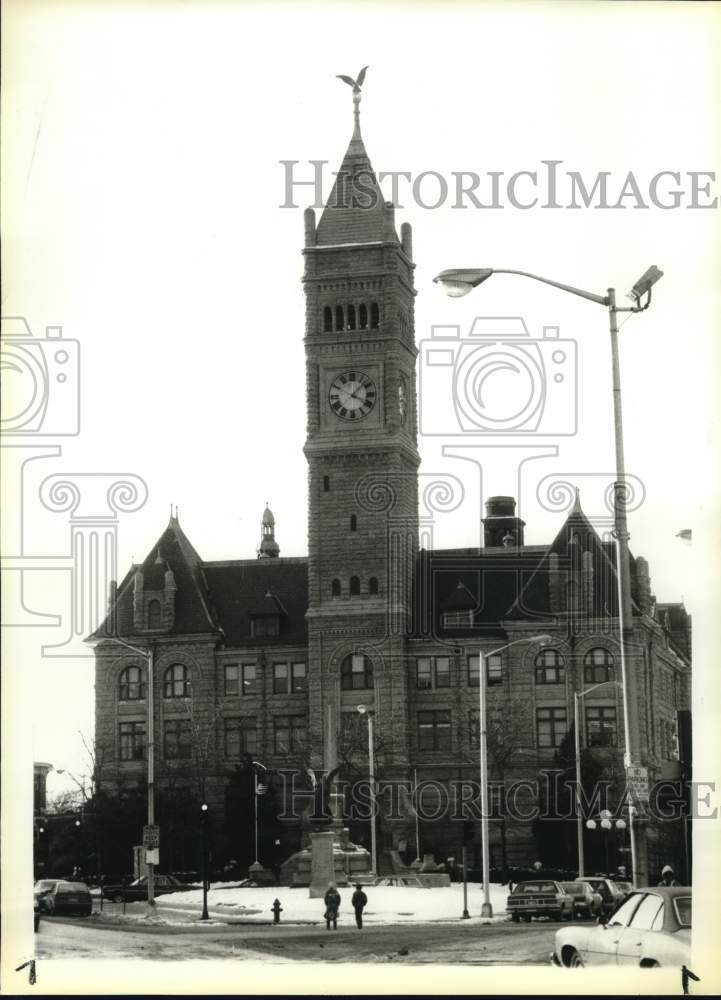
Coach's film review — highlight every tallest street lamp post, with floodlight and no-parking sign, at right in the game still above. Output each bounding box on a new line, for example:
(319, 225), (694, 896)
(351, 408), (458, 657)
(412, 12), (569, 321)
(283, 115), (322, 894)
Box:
(433, 264), (663, 888)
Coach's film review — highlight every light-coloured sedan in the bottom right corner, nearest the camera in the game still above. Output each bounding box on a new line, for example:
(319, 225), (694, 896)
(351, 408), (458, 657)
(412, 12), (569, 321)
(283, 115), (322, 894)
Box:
(551, 885), (691, 968)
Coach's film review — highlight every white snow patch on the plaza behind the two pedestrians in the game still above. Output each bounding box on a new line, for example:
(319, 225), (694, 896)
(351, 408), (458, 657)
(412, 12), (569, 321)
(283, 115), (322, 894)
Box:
(156, 882), (508, 924)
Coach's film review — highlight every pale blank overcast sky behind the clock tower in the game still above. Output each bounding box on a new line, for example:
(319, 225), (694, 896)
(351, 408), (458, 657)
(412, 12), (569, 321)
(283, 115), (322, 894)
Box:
(2, 0), (721, 808)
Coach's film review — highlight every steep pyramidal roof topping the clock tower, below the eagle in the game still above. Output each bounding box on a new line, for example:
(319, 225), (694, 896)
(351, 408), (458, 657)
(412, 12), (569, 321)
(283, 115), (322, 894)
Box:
(316, 122), (398, 246)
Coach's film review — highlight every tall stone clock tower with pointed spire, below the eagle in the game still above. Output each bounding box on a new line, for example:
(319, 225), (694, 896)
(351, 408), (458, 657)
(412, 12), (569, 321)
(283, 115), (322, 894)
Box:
(304, 89), (420, 777)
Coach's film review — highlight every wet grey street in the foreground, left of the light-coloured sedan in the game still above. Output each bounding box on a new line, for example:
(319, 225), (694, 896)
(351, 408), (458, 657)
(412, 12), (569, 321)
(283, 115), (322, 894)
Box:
(36, 918), (559, 965)
